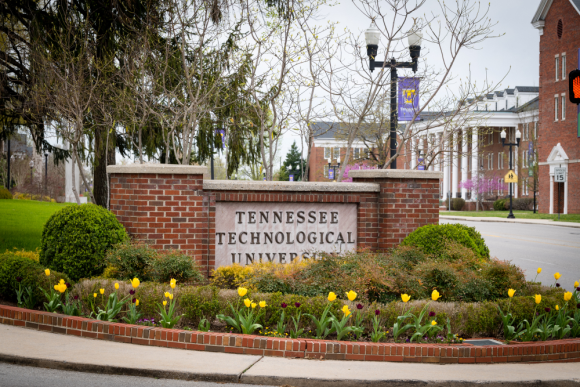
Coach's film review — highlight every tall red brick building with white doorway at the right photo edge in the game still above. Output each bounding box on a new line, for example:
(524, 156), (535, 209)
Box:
(532, 0), (580, 214)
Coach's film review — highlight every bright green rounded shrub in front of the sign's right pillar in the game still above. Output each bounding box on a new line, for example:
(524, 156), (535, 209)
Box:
(401, 224), (489, 258)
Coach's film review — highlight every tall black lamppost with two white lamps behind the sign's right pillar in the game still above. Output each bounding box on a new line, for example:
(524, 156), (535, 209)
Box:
(365, 21), (423, 169)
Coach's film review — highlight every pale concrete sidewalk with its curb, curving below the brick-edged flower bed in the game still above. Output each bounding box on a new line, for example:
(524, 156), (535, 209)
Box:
(0, 325), (580, 387)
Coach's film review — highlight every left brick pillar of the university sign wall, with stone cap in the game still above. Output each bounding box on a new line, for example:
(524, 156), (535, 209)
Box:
(107, 164), (209, 269)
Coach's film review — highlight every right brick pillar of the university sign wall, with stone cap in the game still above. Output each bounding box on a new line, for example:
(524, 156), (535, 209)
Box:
(349, 169), (442, 251)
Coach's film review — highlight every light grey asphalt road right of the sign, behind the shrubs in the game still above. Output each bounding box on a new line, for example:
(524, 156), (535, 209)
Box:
(441, 219), (580, 291)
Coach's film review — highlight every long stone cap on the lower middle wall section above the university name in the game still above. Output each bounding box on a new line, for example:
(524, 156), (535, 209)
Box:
(203, 180), (380, 192)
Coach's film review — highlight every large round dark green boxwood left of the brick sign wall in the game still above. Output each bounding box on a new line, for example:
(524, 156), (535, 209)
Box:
(40, 204), (127, 281)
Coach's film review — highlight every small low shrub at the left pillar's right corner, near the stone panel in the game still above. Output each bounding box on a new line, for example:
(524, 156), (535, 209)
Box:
(149, 250), (205, 283)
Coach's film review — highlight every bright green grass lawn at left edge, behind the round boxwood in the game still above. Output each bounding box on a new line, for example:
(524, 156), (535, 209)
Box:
(0, 199), (74, 252)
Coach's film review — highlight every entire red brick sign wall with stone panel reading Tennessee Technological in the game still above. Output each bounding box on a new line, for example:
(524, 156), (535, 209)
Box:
(107, 164), (441, 275)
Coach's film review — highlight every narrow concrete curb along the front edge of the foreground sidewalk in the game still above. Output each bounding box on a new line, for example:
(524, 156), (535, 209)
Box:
(0, 354), (580, 387)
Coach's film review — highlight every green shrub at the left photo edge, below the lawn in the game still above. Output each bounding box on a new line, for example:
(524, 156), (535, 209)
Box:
(0, 252), (72, 305)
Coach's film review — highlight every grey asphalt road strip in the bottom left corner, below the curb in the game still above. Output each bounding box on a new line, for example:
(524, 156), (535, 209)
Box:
(0, 363), (272, 387)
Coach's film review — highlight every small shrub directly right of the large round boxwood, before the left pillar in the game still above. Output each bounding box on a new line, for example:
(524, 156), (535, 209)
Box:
(103, 240), (158, 281)
